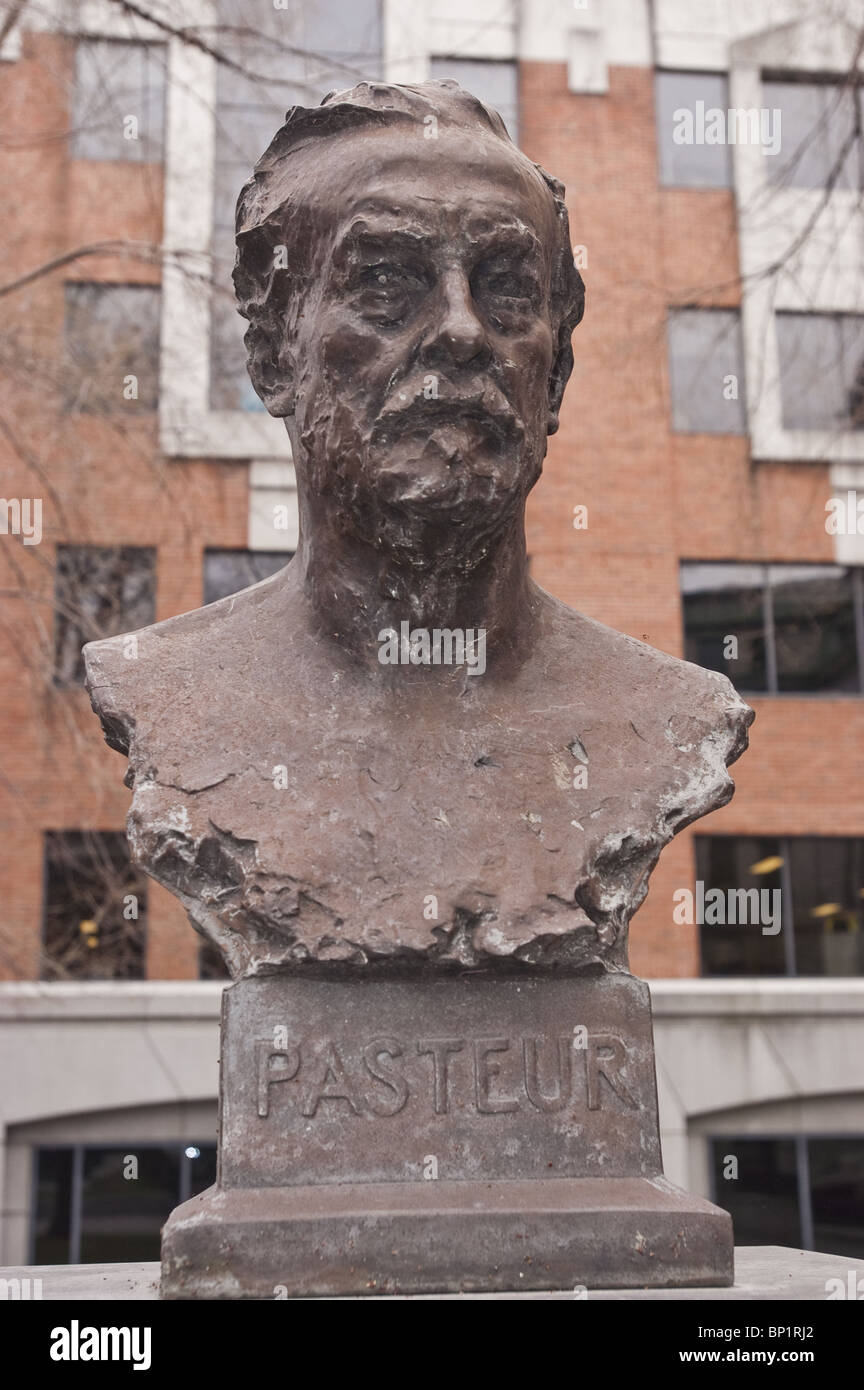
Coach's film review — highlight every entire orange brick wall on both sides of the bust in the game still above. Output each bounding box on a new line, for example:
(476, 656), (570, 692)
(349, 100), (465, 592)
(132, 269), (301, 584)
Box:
(0, 35), (864, 979)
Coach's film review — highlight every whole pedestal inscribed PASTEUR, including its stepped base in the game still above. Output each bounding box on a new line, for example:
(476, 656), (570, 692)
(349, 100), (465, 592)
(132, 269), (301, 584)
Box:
(161, 973), (732, 1298)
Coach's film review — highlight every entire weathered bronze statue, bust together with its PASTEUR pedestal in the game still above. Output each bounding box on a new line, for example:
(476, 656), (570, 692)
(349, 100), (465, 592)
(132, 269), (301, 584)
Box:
(85, 82), (753, 1297)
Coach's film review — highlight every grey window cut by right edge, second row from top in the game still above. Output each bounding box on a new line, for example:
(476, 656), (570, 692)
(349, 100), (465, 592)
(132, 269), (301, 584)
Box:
(774, 313), (864, 430)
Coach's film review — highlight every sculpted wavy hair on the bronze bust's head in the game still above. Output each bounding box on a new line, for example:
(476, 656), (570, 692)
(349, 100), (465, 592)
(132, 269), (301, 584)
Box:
(233, 81), (585, 414)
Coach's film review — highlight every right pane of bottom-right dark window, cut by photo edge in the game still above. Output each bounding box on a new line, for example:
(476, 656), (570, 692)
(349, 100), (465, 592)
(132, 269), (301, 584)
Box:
(807, 1138), (864, 1259)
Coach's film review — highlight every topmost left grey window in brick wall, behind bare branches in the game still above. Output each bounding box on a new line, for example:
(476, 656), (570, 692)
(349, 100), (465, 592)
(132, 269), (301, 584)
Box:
(71, 39), (165, 164)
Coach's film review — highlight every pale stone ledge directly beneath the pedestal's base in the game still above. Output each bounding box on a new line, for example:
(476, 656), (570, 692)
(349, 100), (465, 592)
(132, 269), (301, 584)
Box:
(0, 1245), (864, 1302)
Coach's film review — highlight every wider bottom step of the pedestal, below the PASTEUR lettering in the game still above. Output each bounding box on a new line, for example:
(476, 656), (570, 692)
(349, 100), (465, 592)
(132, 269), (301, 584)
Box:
(161, 1177), (732, 1298)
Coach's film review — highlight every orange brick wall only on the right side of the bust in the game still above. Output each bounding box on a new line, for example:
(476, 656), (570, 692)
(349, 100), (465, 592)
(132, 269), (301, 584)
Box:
(521, 64), (864, 976)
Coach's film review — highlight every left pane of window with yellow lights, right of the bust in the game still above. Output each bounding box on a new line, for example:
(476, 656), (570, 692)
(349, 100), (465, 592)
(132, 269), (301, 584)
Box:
(696, 835), (786, 976)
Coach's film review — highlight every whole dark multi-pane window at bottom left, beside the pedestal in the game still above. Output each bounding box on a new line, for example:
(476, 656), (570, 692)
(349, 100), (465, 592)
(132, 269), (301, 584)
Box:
(31, 1140), (217, 1265)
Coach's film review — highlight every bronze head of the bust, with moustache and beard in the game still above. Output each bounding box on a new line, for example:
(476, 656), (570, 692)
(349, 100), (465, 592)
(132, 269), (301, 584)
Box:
(233, 82), (585, 564)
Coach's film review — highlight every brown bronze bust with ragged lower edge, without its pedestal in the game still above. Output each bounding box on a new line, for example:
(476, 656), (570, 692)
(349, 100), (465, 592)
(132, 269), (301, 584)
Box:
(86, 82), (751, 976)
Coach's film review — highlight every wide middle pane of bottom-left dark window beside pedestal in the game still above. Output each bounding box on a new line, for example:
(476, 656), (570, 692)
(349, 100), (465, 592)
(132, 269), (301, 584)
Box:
(81, 1144), (181, 1265)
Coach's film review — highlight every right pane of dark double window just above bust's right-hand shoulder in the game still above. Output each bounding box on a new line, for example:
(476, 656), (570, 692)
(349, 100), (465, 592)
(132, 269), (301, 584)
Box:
(770, 564), (860, 694)
